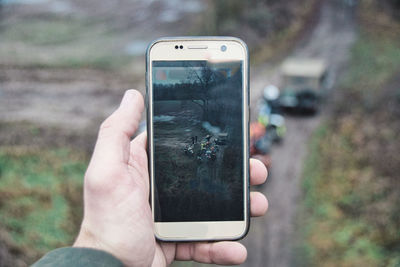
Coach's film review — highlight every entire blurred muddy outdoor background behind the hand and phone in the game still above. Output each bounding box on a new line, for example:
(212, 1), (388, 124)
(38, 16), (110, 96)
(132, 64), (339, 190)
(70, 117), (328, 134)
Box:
(0, 0), (400, 267)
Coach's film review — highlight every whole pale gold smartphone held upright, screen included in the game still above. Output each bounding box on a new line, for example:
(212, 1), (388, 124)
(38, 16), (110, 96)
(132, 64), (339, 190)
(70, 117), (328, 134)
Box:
(146, 37), (249, 241)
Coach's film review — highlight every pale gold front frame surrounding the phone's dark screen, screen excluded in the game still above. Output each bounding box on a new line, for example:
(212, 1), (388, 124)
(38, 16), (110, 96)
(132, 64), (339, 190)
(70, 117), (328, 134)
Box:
(146, 37), (250, 242)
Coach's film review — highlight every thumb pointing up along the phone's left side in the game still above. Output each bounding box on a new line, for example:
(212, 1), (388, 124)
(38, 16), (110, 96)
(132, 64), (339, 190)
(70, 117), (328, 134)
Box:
(92, 89), (144, 166)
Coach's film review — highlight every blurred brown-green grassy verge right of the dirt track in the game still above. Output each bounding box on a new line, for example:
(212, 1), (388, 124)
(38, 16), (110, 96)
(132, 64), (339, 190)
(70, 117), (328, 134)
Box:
(297, 5), (400, 266)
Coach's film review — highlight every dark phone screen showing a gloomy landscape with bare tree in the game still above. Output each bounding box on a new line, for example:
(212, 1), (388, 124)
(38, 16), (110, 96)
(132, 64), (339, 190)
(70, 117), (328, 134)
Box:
(152, 60), (245, 222)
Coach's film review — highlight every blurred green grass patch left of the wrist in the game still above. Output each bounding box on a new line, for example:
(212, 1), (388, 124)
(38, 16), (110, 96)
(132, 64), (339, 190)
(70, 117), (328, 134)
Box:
(0, 146), (87, 260)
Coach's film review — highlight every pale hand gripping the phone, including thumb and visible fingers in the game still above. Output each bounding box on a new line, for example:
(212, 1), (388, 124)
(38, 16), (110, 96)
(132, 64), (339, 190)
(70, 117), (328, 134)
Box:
(74, 90), (268, 266)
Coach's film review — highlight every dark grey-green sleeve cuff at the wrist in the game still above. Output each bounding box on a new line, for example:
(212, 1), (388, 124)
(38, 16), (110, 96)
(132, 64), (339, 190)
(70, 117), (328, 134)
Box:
(32, 247), (123, 267)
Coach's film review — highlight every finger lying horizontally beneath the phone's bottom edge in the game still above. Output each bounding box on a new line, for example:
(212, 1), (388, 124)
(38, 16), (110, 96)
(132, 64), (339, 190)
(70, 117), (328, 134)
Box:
(175, 241), (247, 265)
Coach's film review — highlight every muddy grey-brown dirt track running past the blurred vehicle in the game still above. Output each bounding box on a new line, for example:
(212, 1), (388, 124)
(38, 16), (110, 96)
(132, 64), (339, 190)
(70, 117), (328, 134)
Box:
(243, 1), (356, 267)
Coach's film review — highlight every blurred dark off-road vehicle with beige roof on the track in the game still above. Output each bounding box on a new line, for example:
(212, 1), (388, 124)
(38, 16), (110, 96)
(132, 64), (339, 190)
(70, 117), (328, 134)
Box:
(279, 58), (327, 114)
